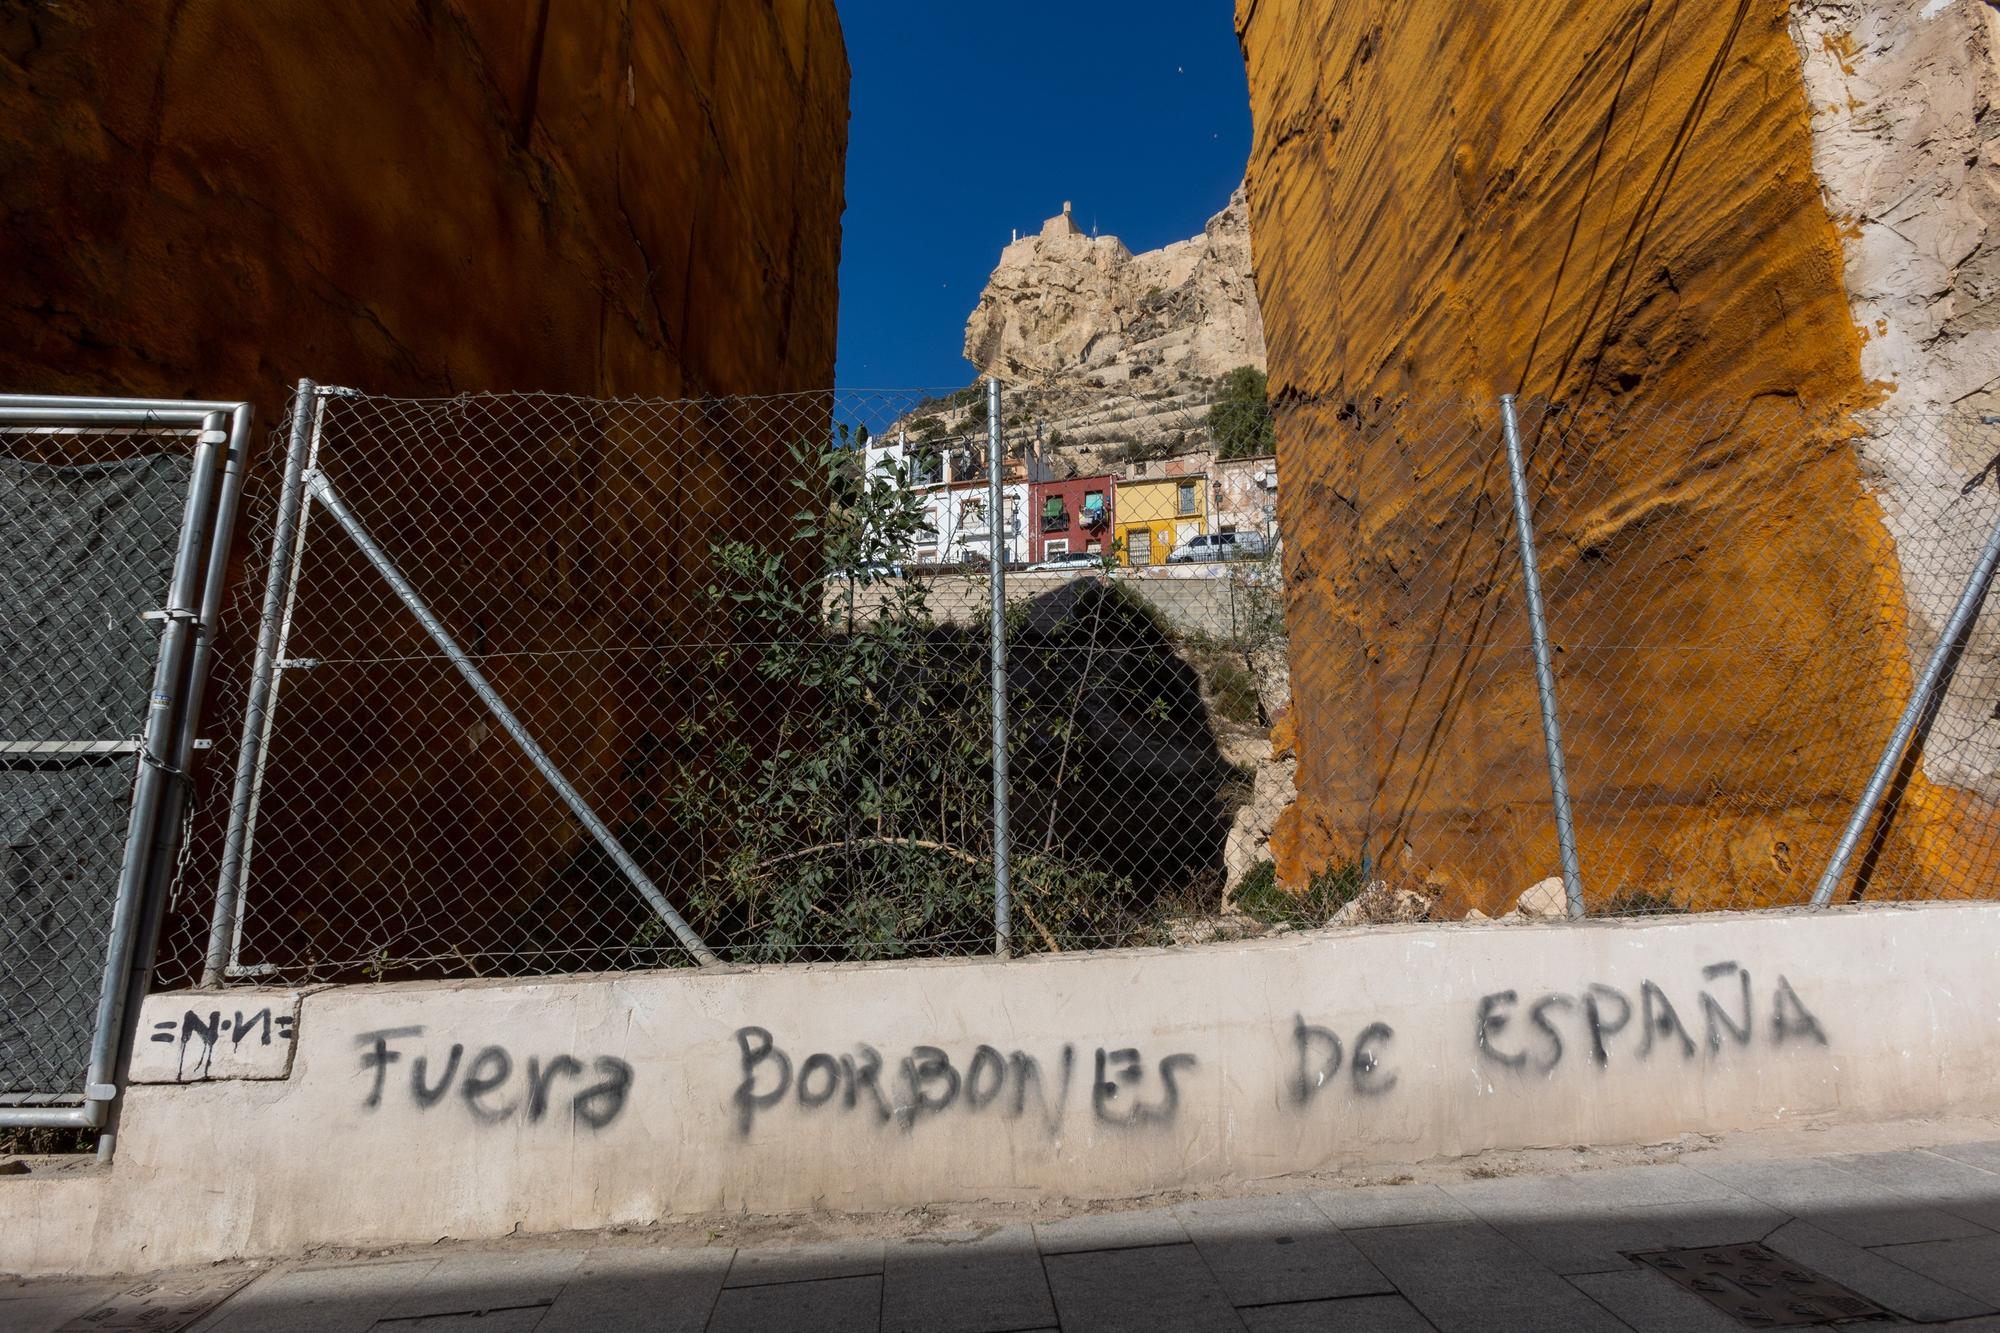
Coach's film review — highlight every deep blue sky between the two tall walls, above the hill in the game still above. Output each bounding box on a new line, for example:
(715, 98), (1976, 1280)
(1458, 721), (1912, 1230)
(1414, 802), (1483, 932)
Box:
(836, 0), (1250, 388)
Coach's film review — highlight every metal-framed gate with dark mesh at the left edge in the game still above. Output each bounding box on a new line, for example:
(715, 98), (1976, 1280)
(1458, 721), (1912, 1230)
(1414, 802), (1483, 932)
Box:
(0, 394), (250, 1153)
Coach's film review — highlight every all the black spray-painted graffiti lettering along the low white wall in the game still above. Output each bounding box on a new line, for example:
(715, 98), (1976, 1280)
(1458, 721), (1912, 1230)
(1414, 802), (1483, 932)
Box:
(340, 961), (1828, 1137)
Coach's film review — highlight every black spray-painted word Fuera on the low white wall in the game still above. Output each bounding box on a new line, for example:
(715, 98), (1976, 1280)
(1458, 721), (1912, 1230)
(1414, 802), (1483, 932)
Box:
(354, 1025), (632, 1129)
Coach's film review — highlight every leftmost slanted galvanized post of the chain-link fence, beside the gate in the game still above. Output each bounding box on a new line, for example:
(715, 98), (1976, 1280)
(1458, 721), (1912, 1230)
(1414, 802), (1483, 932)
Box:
(202, 380), (320, 987)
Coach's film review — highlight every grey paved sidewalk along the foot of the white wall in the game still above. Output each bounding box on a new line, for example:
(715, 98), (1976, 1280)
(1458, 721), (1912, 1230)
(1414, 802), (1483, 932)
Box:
(11, 1133), (2000, 1333)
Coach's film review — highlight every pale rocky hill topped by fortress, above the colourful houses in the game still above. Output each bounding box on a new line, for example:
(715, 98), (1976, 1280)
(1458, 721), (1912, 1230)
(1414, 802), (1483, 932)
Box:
(966, 188), (1264, 474)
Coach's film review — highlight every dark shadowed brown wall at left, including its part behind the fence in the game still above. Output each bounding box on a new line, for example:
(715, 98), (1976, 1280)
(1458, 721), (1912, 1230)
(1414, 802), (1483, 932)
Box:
(0, 0), (848, 967)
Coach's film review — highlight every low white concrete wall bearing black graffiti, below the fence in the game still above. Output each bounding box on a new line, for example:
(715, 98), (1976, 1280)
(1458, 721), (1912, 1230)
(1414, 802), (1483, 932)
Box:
(11, 905), (2000, 1273)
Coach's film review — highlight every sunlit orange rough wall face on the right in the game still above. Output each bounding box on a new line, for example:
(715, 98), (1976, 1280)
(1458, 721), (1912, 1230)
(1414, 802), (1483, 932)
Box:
(1236, 0), (1968, 913)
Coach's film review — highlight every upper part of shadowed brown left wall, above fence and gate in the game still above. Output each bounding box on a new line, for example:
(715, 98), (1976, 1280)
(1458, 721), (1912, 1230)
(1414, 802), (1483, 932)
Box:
(0, 0), (848, 404)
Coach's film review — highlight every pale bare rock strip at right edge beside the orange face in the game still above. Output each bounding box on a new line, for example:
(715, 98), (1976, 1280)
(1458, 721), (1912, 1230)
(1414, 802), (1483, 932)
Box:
(1792, 0), (2000, 840)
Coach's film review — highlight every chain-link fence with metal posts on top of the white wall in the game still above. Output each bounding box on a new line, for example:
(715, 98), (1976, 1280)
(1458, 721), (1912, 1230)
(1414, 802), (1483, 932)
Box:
(148, 376), (2000, 983)
